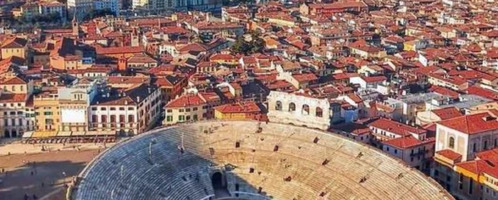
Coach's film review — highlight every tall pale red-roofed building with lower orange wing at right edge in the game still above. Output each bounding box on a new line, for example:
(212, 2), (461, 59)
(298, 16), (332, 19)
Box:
(431, 112), (498, 200)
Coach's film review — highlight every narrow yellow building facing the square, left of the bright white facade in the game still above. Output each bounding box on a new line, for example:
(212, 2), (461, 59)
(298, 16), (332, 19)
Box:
(33, 88), (60, 134)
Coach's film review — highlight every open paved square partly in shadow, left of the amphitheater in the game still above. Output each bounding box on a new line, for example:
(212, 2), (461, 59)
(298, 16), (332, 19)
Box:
(0, 150), (99, 200)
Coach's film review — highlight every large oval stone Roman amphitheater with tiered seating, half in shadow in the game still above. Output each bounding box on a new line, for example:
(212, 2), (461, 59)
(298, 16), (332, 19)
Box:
(67, 121), (453, 200)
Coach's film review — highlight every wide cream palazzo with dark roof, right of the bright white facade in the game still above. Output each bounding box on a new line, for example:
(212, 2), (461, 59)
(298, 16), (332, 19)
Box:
(88, 84), (161, 136)
